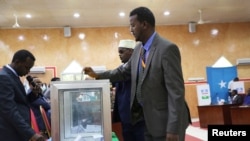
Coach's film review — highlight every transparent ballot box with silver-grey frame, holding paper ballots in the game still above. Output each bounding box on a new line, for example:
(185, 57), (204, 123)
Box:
(50, 80), (112, 141)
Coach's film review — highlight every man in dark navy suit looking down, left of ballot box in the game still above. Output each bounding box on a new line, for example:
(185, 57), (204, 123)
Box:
(0, 50), (45, 141)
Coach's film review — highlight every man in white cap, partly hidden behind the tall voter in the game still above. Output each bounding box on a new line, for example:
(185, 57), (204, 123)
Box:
(112, 39), (145, 141)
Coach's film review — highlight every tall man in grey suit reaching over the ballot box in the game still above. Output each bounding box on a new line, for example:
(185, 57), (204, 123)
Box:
(84, 7), (191, 141)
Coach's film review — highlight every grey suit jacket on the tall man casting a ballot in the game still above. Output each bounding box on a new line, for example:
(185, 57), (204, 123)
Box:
(96, 34), (190, 136)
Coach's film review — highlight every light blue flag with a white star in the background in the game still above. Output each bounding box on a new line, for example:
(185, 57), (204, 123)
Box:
(206, 66), (238, 104)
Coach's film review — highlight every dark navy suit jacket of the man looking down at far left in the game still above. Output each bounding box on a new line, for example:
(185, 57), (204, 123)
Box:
(0, 66), (35, 141)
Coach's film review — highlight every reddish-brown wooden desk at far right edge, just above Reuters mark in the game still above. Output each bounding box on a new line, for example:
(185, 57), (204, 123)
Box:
(230, 106), (250, 125)
